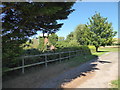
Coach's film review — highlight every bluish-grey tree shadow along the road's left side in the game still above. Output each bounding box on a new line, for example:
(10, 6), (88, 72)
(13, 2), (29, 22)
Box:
(40, 56), (100, 88)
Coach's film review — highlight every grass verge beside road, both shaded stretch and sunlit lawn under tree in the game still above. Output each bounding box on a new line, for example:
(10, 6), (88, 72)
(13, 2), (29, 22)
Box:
(61, 47), (118, 67)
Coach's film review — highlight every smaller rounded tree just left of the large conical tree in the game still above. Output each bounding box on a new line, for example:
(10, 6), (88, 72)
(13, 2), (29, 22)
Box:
(74, 24), (90, 45)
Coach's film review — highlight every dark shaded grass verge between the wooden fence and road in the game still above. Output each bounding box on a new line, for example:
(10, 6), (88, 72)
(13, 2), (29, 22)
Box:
(46, 55), (97, 72)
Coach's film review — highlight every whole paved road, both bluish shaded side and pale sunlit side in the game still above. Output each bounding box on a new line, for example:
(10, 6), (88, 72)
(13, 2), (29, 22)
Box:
(42, 52), (118, 88)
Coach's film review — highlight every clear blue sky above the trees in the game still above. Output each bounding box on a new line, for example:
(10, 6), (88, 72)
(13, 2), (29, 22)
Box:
(57, 2), (118, 37)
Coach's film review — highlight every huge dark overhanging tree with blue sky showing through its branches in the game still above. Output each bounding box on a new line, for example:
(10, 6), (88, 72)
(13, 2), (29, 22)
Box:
(1, 2), (74, 67)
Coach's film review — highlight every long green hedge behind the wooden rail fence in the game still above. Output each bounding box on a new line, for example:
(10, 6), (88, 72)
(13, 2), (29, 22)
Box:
(3, 41), (95, 72)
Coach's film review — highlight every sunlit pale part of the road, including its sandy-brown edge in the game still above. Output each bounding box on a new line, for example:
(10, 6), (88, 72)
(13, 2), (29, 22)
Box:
(63, 52), (118, 88)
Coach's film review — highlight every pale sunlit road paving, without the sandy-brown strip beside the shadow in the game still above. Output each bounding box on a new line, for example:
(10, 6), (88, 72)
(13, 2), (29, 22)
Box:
(77, 52), (118, 88)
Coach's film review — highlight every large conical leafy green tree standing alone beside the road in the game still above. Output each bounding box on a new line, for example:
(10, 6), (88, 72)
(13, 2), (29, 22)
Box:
(87, 13), (117, 51)
